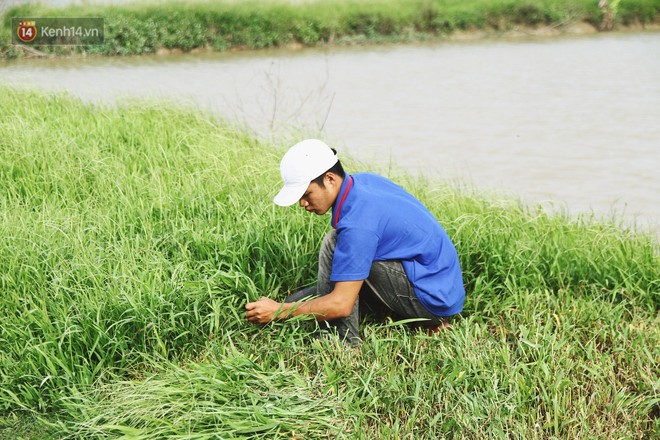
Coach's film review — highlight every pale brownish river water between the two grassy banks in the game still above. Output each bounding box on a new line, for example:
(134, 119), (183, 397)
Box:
(0, 32), (660, 233)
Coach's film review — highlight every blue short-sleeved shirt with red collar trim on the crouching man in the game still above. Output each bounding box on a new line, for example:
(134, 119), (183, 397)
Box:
(330, 173), (465, 316)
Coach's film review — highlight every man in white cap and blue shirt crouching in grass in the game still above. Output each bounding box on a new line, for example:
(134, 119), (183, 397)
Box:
(245, 139), (465, 345)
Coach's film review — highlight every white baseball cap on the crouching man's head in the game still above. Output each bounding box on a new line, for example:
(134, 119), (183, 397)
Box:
(273, 139), (339, 206)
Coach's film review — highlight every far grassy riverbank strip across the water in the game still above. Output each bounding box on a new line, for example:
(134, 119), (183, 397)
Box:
(0, 0), (660, 57)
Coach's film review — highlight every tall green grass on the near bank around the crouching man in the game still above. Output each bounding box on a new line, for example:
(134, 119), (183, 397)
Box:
(0, 87), (660, 439)
